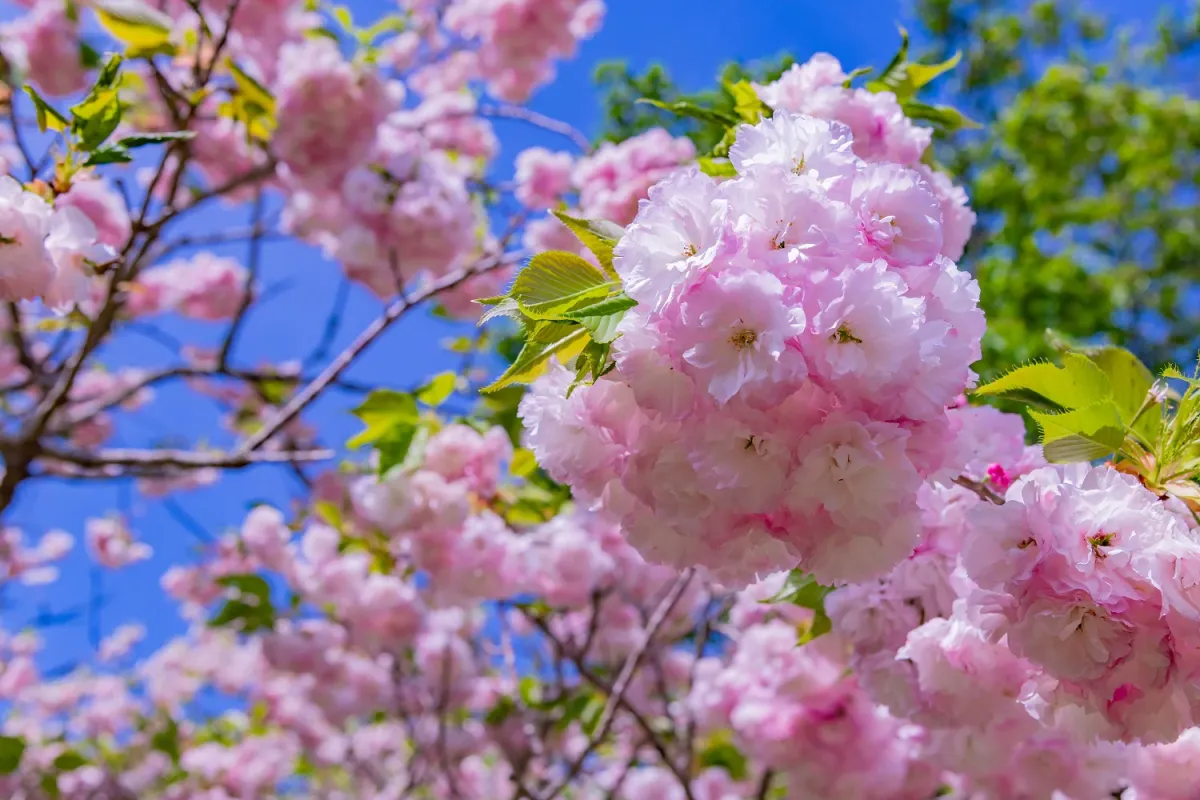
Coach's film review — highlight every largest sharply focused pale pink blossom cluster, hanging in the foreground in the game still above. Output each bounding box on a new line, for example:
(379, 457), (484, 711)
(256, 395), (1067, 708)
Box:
(522, 114), (984, 584)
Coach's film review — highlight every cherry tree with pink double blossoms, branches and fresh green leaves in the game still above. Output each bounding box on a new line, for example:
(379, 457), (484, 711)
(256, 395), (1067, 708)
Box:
(0, 0), (1200, 800)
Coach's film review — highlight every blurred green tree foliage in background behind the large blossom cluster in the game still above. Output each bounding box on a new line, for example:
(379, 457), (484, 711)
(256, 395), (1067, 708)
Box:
(596, 0), (1200, 377)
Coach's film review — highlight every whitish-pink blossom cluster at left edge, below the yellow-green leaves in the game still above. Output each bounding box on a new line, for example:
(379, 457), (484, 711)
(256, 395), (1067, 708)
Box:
(0, 175), (113, 308)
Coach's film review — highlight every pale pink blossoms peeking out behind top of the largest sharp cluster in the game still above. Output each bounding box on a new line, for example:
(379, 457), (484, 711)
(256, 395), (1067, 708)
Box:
(756, 53), (976, 259)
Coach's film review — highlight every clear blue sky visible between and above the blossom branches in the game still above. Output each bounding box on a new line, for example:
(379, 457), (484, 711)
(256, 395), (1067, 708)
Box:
(0, 0), (1180, 668)
